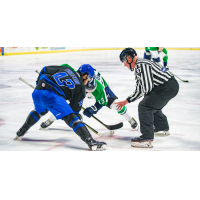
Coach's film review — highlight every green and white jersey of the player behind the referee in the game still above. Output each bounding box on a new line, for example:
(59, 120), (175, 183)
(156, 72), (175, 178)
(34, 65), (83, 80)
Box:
(145, 47), (168, 63)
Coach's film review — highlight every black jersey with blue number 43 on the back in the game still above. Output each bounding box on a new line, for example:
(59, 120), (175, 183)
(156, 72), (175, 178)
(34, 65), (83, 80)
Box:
(36, 65), (86, 112)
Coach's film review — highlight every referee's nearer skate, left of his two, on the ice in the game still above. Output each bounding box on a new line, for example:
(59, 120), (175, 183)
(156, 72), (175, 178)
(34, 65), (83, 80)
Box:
(131, 137), (153, 148)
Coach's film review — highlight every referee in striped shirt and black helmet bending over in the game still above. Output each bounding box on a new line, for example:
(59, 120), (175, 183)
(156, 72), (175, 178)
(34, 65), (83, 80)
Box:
(116, 48), (179, 148)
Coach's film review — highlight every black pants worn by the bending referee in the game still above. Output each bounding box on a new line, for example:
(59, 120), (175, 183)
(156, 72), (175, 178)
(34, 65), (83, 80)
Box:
(138, 78), (179, 139)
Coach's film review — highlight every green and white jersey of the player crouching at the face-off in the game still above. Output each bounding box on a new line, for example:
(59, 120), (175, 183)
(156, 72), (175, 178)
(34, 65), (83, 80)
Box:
(86, 70), (108, 106)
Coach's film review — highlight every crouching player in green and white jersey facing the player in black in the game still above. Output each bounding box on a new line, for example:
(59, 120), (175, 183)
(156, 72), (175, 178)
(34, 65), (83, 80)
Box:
(41, 64), (139, 130)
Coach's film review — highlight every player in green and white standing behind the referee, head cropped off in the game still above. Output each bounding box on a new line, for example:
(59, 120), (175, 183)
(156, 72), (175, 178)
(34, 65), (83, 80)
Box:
(144, 47), (169, 72)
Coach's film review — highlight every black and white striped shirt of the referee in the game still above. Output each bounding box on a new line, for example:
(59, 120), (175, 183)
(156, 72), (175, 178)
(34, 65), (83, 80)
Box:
(127, 58), (173, 103)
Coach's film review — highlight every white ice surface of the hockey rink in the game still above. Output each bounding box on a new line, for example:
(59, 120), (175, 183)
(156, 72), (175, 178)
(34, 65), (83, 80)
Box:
(0, 50), (200, 151)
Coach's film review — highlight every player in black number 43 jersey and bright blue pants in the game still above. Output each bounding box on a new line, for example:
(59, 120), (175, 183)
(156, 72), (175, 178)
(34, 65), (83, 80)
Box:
(15, 64), (106, 150)
